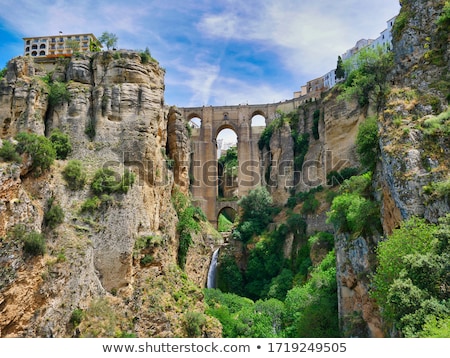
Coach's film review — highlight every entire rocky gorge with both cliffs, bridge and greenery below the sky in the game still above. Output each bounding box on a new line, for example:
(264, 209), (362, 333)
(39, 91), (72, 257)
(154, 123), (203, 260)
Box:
(0, 0), (450, 338)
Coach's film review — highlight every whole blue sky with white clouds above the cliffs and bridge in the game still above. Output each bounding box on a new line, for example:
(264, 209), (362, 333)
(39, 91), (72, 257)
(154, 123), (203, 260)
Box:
(0, 0), (400, 107)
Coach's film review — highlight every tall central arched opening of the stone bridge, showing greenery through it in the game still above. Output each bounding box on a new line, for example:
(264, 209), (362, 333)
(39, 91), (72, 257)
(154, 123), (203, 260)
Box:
(217, 128), (239, 200)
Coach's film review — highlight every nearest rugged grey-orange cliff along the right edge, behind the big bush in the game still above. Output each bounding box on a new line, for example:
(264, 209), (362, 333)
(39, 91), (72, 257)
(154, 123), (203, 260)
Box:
(336, 1), (450, 337)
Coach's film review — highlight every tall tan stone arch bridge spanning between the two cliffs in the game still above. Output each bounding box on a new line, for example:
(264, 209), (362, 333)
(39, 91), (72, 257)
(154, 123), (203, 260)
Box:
(178, 99), (301, 225)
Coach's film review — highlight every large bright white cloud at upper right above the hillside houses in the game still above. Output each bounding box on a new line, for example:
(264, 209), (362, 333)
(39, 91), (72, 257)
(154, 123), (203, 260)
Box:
(198, 0), (399, 75)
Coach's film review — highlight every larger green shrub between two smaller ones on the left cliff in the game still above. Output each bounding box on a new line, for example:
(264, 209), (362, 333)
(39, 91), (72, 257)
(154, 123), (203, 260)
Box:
(16, 132), (56, 175)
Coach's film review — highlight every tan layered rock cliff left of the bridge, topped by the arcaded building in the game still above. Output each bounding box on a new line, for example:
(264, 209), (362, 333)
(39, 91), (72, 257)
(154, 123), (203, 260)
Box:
(0, 52), (220, 337)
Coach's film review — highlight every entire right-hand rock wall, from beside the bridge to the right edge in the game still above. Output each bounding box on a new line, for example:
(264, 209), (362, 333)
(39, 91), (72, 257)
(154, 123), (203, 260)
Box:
(255, 0), (450, 337)
